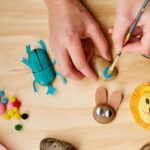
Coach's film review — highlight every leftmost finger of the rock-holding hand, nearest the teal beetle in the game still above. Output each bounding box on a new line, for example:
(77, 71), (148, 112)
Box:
(50, 45), (83, 80)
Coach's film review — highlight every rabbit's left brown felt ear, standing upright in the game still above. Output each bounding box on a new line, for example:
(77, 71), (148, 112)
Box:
(95, 87), (107, 105)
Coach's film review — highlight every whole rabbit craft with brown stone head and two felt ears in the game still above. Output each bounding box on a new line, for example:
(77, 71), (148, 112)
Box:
(93, 87), (123, 124)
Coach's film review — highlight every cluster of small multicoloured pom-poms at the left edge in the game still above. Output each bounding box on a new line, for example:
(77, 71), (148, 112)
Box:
(0, 90), (29, 131)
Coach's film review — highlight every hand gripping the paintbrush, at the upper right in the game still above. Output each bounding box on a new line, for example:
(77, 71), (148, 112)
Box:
(109, 0), (150, 55)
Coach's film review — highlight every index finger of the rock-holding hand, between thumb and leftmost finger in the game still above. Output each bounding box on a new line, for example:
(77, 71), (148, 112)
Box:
(66, 36), (97, 80)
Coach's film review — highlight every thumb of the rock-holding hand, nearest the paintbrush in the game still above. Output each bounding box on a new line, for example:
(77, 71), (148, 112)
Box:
(87, 23), (111, 61)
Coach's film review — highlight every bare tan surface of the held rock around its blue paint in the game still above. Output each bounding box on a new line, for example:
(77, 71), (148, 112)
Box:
(90, 55), (118, 80)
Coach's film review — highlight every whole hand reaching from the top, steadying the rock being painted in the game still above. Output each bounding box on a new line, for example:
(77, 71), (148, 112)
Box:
(45, 0), (111, 80)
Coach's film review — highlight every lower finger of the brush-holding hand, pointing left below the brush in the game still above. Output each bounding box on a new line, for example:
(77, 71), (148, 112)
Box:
(123, 32), (150, 56)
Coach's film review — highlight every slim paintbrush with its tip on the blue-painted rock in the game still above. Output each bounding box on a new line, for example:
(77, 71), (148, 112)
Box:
(107, 0), (149, 74)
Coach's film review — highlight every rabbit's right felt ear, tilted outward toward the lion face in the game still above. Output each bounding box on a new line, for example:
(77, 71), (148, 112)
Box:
(108, 91), (123, 111)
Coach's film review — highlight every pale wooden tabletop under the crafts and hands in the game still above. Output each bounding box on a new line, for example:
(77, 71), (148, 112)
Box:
(0, 0), (150, 150)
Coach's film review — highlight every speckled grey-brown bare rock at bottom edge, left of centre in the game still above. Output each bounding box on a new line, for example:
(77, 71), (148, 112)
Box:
(40, 138), (76, 150)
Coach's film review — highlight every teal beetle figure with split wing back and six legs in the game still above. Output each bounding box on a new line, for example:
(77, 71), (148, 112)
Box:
(22, 40), (66, 94)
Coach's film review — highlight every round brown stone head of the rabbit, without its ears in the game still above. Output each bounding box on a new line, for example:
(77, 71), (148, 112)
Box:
(93, 104), (116, 124)
